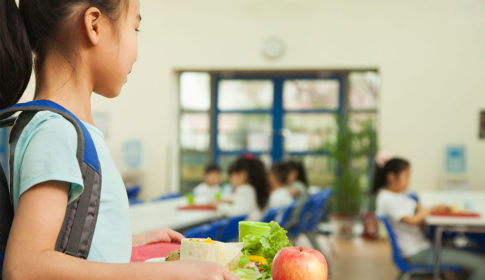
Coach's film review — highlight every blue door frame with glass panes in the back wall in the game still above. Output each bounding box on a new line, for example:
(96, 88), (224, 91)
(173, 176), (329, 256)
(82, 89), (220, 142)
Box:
(211, 75), (345, 163)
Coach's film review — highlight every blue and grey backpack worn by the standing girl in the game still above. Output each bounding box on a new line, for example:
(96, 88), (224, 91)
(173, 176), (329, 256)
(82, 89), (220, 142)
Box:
(0, 100), (101, 280)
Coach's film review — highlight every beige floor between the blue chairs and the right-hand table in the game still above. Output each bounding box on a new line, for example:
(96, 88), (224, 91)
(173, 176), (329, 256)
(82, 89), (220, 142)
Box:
(296, 237), (399, 280)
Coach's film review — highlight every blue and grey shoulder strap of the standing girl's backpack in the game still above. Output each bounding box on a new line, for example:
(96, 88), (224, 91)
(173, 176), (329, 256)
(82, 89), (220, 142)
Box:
(0, 100), (101, 259)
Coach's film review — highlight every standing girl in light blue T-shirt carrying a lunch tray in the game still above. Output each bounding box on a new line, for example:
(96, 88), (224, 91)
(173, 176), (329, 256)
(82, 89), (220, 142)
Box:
(0, 0), (237, 280)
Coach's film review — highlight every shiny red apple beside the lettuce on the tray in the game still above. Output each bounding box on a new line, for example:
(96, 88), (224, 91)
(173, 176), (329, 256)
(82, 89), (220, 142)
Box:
(272, 247), (328, 280)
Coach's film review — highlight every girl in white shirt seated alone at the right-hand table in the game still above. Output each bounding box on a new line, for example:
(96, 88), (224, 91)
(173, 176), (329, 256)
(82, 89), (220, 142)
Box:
(373, 158), (485, 280)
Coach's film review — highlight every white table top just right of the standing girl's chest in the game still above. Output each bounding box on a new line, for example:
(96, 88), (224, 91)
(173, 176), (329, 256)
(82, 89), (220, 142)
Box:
(130, 197), (223, 234)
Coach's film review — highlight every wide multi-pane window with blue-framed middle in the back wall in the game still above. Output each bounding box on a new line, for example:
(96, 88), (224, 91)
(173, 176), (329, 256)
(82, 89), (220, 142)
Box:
(179, 71), (380, 192)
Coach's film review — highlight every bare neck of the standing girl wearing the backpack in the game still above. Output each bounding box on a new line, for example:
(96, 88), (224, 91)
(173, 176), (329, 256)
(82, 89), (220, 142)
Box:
(35, 57), (94, 125)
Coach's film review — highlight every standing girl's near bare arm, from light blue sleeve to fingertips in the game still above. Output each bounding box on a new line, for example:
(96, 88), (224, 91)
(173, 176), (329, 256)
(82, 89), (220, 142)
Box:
(3, 181), (238, 280)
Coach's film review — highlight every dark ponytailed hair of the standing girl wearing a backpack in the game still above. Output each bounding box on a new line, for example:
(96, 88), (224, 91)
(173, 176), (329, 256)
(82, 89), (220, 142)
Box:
(0, 0), (128, 109)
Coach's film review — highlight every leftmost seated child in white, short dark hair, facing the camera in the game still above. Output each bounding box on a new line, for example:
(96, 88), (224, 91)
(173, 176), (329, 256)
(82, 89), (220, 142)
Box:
(194, 164), (221, 204)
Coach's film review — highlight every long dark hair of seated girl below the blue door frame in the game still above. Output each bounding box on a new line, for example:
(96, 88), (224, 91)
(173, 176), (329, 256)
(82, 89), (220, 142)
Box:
(228, 157), (270, 210)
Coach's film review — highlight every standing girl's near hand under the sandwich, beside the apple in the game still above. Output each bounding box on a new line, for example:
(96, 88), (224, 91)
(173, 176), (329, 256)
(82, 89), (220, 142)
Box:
(164, 261), (239, 280)
